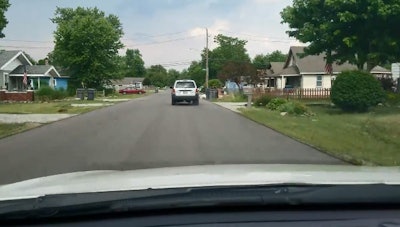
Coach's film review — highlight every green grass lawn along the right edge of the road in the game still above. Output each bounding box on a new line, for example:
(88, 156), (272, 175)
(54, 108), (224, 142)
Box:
(241, 105), (400, 166)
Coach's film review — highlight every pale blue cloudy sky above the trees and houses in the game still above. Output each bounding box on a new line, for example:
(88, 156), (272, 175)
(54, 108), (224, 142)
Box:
(0, 0), (301, 70)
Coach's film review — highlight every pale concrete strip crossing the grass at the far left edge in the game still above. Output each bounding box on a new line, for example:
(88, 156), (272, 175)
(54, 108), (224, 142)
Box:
(0, 114), (76, 123)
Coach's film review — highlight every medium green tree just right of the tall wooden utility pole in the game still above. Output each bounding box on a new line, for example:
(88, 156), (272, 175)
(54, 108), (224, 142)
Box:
(202, 34), (250, 79)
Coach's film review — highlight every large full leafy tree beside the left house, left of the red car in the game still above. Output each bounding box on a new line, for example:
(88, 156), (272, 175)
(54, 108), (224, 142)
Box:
(51, 7), (123, 88)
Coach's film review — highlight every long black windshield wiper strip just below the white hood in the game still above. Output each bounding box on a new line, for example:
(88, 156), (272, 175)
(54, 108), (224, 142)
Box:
(0, 185), (400, 219)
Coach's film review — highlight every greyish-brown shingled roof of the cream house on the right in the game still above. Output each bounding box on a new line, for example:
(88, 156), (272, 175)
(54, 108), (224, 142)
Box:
(284, 46), (357, 73)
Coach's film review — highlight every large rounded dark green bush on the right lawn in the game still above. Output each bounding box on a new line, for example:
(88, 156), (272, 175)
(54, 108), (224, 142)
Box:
(331, 71), (384, 112)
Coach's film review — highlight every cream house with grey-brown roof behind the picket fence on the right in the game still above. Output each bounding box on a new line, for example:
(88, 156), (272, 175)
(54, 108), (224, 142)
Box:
(270, 46), (391, 89)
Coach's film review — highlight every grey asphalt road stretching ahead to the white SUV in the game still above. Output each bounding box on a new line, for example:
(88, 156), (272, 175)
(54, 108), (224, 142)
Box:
(0, 92), (342, 184)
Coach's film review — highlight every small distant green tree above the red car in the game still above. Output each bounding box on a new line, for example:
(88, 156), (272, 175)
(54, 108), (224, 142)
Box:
(125, 49), (146, 77)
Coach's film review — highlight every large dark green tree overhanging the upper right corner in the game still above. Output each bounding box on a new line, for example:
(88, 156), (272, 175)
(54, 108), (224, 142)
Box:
(281, 0), (400, 71)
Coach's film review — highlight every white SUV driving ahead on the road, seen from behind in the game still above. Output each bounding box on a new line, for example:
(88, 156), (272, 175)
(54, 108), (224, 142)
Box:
(171, 80), (199, 105)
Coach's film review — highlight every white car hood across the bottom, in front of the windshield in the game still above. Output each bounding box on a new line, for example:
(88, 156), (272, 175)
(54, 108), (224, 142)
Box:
(0, 164), (400, 200)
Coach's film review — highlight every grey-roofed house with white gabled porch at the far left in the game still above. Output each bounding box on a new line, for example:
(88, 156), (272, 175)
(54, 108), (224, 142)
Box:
(0, 50), (65, 101)
